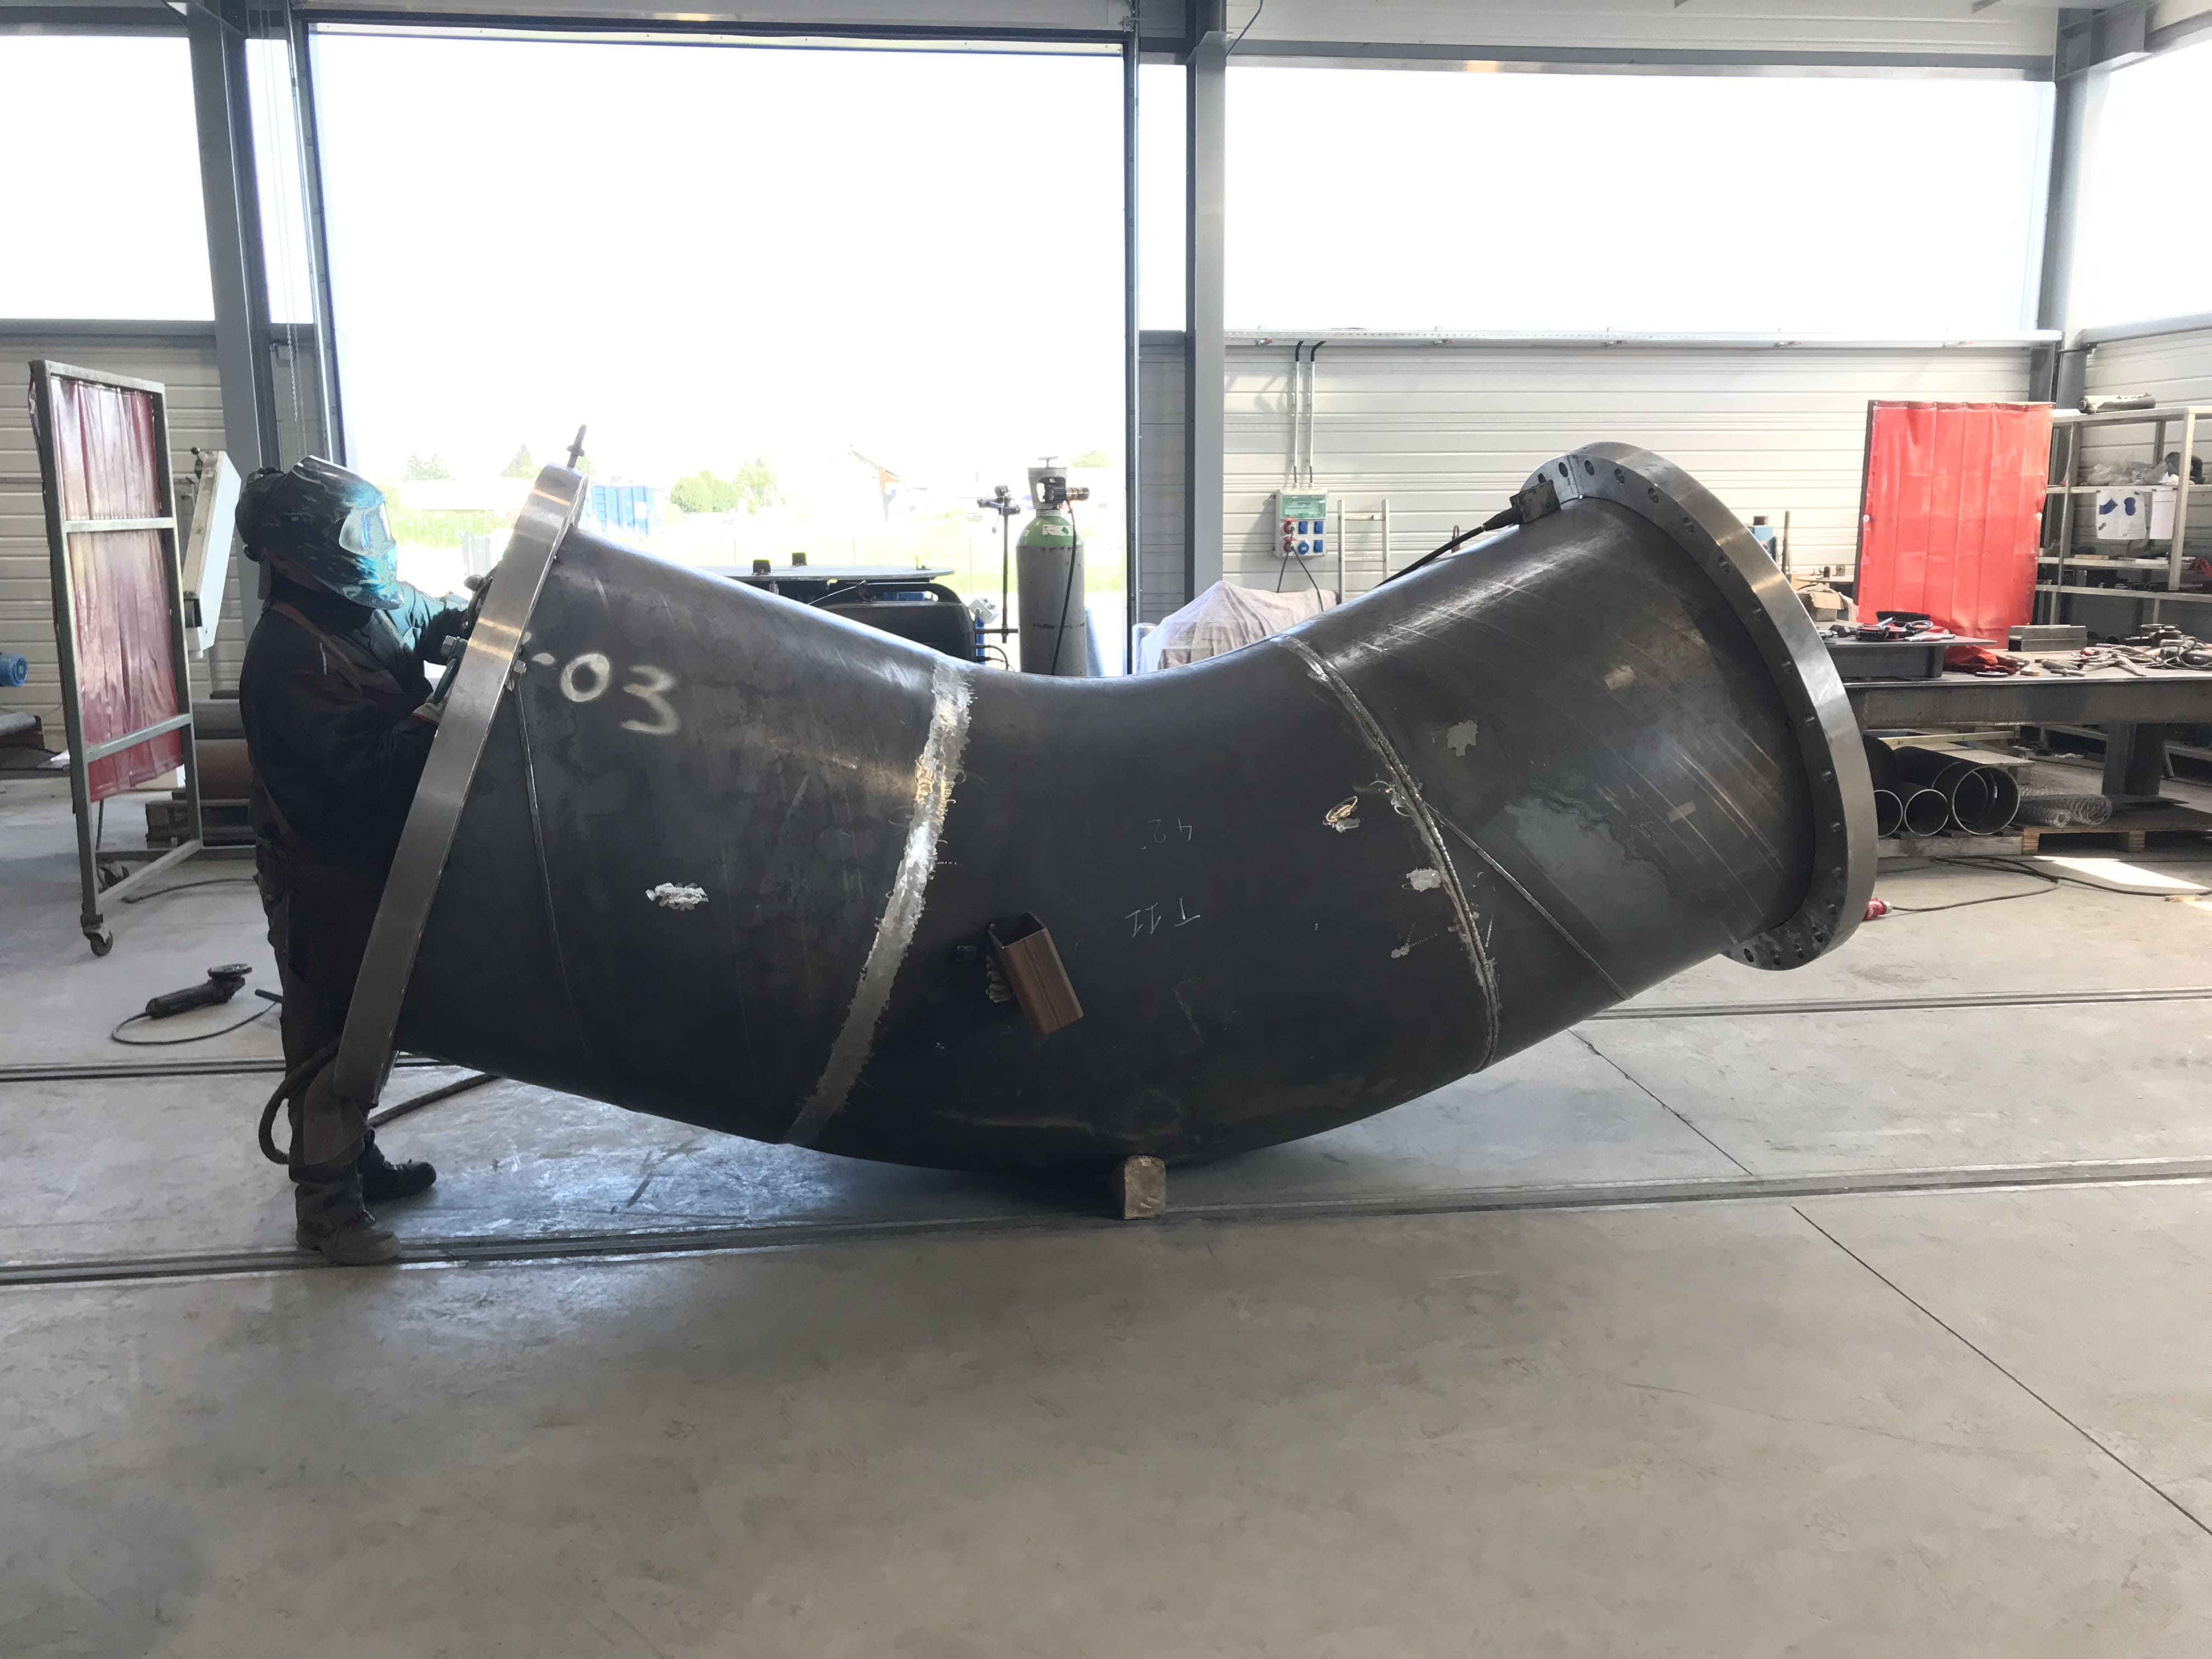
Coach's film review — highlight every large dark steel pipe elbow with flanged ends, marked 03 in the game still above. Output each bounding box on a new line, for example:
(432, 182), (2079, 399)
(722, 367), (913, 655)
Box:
(338, 444), (1874, 1168)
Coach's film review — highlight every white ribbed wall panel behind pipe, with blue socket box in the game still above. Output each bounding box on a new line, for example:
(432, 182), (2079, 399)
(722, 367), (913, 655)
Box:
(1226, 345), (2028, 593)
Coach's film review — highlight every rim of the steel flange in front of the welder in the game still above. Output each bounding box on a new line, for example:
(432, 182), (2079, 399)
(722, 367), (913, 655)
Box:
(336, 467), (584, 1102)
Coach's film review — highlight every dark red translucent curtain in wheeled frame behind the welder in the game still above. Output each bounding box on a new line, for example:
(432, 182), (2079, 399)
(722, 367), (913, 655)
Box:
(49, 374), (184, 801)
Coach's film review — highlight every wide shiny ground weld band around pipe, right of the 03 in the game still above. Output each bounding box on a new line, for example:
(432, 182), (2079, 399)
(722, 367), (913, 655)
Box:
(783, 662), (969, 1146)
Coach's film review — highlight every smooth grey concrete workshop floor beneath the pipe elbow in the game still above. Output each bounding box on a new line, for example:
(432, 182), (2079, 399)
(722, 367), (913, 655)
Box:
(0, 783), (2212, 1659)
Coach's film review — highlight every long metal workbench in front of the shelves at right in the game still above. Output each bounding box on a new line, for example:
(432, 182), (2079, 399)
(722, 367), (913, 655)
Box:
(1843, 650), (2212, 801)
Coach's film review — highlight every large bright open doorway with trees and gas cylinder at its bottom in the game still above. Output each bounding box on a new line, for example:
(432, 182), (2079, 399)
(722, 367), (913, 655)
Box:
(314, 31), (1124, 597)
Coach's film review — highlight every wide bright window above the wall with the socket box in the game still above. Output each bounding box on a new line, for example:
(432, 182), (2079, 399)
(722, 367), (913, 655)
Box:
(1228, 66), (2051, 336)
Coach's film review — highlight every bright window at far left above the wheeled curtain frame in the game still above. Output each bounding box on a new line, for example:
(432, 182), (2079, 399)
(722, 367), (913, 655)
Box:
(0, 36), (215, 321)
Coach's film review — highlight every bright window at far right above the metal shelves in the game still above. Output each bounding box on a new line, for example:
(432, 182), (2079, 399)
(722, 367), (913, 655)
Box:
(2066, 42), (2212, 328)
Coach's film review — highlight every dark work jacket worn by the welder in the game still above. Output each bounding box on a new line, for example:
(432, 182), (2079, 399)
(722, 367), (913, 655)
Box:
(239, 575), (438, 881)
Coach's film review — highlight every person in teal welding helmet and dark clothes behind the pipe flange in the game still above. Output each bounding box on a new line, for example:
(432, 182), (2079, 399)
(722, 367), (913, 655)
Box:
(239, 458), (467, 1265)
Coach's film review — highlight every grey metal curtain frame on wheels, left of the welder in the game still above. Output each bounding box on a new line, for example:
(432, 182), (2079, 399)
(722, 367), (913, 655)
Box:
(31, 360), (204, 956)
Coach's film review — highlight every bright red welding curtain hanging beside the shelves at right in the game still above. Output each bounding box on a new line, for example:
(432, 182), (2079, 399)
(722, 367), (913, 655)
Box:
(1858, 403), (2051, 644)
